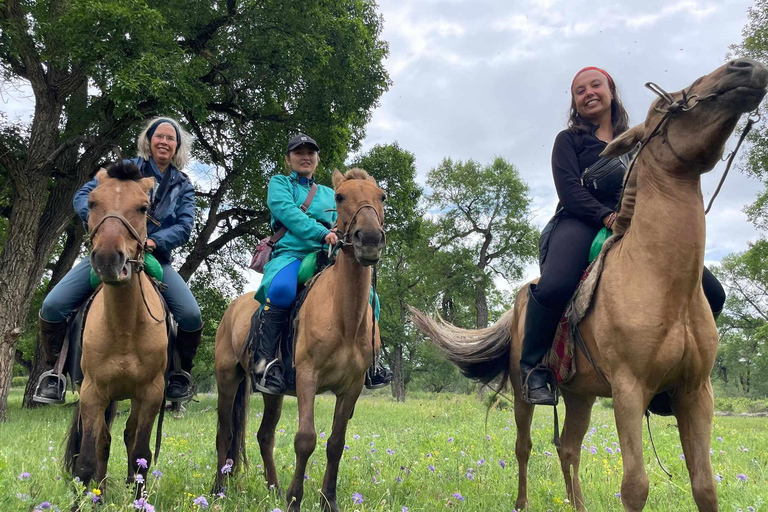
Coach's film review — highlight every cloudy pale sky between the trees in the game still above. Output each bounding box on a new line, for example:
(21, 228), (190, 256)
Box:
(363, 0), (761, 277)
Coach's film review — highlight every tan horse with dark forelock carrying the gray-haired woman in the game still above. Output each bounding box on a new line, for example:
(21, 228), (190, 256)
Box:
(64, 164), (168, 495)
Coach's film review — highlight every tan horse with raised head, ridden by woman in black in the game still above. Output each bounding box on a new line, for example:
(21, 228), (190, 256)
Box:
(414, 59), (768, 511)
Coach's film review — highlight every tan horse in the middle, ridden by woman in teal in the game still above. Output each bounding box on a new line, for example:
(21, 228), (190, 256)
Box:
(215, 169), (385, 511)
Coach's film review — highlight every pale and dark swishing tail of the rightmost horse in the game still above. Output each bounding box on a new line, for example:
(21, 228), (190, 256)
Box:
(411, 308), (514, 384)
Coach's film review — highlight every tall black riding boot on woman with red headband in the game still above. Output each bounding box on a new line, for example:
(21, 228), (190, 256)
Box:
(520, 284), (562, 405)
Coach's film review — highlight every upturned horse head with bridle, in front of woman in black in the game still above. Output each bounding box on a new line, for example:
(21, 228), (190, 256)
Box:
(602, 59), (768, 176)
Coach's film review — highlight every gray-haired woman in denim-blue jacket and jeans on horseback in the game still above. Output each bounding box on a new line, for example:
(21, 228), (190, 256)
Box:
(34, 117), (203, 403)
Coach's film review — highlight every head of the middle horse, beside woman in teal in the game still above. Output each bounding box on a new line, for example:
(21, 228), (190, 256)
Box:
(333, 169), (387, 266)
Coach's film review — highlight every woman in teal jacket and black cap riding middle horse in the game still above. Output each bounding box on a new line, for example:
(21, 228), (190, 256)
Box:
(254, 134), (392, 395)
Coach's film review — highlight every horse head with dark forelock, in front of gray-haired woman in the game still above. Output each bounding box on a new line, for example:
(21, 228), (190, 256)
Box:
(88, 162), (155, 284)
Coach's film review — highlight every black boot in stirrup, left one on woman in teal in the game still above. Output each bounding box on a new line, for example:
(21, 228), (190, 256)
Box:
(253, 303), (291, 395)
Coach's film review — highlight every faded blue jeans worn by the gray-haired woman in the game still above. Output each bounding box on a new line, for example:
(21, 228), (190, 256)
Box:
(40, 258), (203, 332)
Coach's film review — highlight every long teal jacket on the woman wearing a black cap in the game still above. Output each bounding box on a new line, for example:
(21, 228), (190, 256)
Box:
(256, 171), (336, 304)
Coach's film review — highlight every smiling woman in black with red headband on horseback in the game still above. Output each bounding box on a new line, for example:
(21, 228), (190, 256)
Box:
(520, 67), (725, 405)
